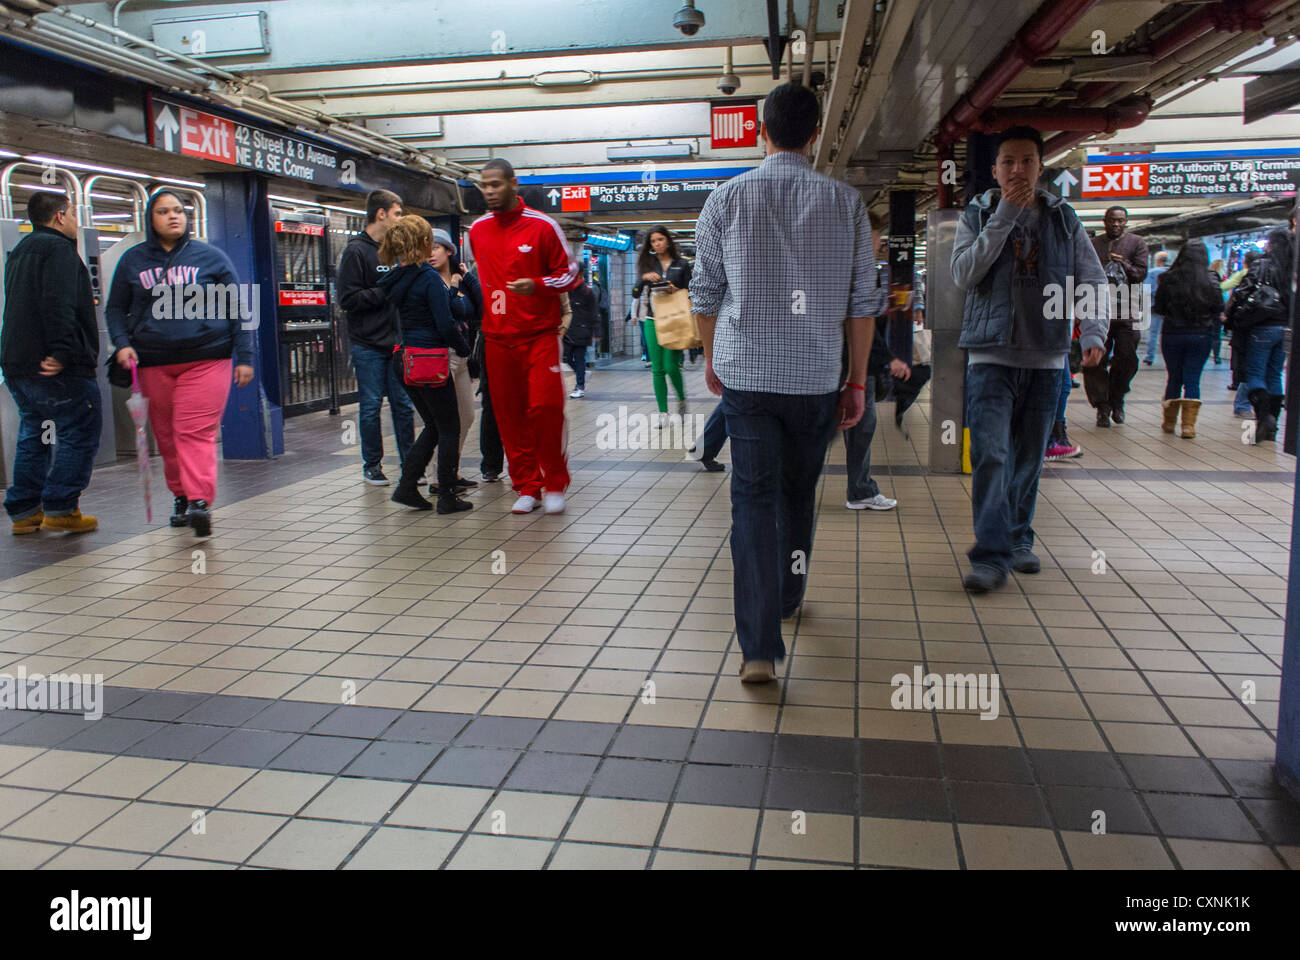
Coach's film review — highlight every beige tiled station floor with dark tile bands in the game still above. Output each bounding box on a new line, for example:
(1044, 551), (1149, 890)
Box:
(0, 362), (1300, 869)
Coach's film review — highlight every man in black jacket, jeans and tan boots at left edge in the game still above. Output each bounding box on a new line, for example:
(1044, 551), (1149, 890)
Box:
(0, 191), (101, 535)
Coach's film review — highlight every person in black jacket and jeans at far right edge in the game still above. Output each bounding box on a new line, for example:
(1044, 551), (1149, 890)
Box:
(1229, 228), (1295, 444)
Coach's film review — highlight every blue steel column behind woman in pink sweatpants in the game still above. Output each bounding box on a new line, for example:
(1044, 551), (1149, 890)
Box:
(204, 173), (285, 460)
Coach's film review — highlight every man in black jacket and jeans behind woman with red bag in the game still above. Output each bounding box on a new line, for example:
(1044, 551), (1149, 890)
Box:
(335, 190), (415, 487)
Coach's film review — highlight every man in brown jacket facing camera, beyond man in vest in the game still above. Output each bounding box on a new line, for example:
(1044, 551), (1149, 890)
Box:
(1083, 207), (1147, 427)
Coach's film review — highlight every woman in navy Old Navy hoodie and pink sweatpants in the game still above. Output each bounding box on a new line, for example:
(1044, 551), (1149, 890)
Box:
(105, 187), (256, 537)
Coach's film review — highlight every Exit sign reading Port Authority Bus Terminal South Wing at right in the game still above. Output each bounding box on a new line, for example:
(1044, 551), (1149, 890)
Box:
(1048, 152), (1300, 200)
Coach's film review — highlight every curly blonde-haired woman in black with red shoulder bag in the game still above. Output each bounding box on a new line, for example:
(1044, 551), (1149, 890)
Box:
(380, 216), (473, 514)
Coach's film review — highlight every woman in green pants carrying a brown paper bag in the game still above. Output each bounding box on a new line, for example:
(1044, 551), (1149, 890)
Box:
(632, 225), (694, 427)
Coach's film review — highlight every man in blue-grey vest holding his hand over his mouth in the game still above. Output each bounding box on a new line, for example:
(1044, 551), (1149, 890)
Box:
(952, 126), (1110, 593)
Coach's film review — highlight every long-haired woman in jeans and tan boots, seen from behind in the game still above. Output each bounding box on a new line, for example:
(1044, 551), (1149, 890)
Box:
(1153, 241), (1223, 440)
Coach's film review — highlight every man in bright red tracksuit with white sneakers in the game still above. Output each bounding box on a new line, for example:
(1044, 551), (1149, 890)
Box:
(469, 159), (581, 514)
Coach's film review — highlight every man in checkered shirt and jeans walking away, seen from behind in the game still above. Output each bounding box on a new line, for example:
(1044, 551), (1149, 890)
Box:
(690, 83), (887, 683)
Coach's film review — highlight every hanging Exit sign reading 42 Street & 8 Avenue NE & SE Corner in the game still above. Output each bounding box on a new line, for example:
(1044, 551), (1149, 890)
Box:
(150, 94), (358, 189)
